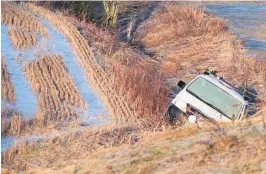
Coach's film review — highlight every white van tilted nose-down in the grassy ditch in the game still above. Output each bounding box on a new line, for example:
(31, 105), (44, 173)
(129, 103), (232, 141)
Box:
(166, 73), (248, 123)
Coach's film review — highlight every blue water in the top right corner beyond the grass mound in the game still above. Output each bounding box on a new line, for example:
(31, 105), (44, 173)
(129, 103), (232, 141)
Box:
(205, 3), (266, 60)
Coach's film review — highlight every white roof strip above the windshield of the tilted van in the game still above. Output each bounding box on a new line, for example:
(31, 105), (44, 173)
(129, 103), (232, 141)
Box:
(193, 74), (245, 103)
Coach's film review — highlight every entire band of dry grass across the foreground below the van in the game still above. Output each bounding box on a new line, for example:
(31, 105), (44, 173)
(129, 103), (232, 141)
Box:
(3, 112), (266, 173)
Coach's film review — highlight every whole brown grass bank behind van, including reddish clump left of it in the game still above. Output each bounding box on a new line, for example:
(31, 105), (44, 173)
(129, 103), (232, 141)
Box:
(68, 4), (266, 119)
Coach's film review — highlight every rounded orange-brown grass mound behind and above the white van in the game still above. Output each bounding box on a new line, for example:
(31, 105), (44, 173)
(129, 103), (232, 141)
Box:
(133, 3), (266, 97)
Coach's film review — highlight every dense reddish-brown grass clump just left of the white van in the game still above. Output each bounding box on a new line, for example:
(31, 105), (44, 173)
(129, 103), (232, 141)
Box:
(112, 60), (169, 121)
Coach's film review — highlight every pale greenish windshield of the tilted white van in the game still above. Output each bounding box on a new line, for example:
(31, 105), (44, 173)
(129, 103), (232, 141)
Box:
(187, 77), (242, 119)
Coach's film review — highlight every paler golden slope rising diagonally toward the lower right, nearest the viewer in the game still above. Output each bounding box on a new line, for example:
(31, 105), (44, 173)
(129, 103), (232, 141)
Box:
(18, 117), (266, 173)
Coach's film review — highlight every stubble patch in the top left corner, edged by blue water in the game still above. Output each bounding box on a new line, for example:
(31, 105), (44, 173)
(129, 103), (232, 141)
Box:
(1, 2), (49, 49)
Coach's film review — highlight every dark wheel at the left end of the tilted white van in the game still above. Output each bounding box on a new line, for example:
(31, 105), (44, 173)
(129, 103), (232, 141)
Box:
(166, 105), (186, 125)
